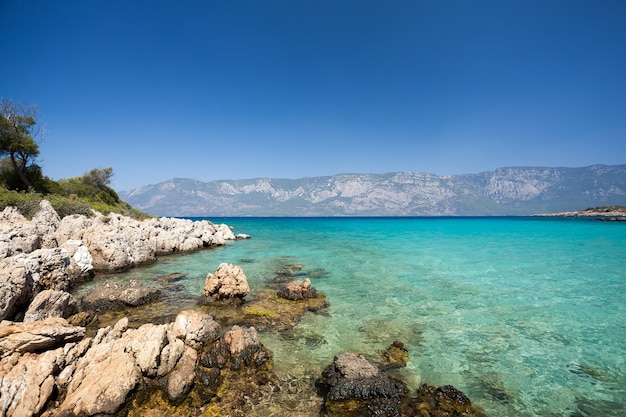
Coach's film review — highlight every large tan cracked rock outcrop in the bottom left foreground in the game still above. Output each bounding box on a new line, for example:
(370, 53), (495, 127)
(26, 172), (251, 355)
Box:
(0, 311), (219, 416)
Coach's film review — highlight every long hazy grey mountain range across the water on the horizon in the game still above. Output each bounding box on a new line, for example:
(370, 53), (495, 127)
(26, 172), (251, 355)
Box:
(119, 165), (626, 217)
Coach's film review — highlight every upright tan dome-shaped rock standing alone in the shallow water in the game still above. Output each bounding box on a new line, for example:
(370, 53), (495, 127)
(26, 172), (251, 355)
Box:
(203, 263), (250, 303)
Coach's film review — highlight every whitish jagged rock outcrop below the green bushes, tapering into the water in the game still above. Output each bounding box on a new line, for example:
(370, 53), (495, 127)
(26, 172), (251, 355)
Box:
(0, 200), (235, 320)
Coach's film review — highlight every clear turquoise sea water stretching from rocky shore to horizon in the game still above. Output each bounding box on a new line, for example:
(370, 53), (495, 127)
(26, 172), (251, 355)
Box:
(84, 218), (626, 416)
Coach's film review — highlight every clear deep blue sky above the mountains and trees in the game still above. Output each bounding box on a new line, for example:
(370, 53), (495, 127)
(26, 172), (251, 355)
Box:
(0, 0), (626, 190)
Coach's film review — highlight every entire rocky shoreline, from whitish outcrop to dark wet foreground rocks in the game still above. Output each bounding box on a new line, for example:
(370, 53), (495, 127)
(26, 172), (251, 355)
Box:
(0, 201), (483, 417)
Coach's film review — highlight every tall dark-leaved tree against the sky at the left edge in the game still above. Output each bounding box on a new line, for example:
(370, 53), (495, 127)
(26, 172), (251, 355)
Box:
(0, 98), (41, 189)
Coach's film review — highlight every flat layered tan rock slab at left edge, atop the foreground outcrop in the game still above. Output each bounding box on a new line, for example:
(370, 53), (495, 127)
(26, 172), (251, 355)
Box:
(0, 317), (85, 357)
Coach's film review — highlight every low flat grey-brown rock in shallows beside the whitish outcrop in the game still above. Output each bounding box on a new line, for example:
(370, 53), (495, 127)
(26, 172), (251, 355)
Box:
(82, 280), (161, 310)
